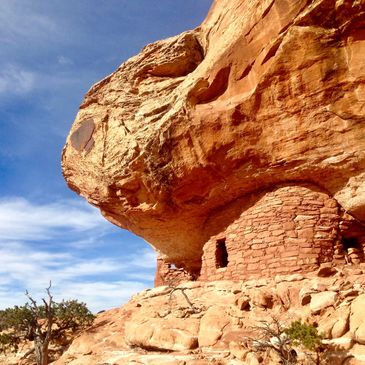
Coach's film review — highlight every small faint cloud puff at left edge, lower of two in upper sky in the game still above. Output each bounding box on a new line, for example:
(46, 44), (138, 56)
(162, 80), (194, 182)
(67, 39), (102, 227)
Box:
(0, 65), (35, 95)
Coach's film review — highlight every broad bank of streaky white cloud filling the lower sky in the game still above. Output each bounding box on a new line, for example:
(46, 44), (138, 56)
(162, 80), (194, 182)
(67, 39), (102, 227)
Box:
(0, 198), (155, 311)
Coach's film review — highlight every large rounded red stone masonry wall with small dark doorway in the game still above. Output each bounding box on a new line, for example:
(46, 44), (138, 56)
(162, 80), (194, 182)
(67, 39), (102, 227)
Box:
(199, 185), (344, 281)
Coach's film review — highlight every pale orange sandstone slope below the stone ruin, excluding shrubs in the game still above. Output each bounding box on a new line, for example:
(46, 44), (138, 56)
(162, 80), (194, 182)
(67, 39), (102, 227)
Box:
(1, 264), (365, 365)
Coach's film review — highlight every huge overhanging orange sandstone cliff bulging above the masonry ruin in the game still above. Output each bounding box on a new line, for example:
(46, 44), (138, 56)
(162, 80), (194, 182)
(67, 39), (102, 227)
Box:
(62, 0), (365, 274)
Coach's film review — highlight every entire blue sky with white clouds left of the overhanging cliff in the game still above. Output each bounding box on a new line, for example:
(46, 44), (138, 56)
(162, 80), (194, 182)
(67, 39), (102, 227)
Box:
(0, 0), (211, 311)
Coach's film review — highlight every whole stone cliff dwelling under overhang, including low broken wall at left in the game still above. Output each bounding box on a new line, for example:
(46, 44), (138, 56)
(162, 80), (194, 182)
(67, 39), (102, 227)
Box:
(155, 184), (365, 285)
